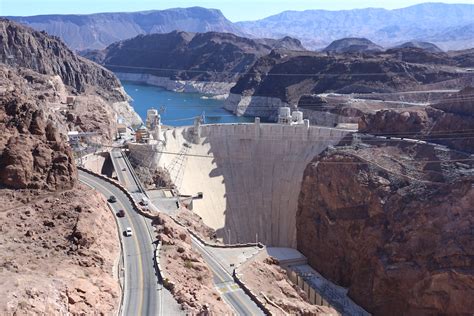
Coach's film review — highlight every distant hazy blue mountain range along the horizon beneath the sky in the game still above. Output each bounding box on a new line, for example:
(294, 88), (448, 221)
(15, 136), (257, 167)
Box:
(4, 3), (474, 50)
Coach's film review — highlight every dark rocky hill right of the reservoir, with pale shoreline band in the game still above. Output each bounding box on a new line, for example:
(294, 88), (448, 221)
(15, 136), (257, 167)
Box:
(226, 51), (472, 116)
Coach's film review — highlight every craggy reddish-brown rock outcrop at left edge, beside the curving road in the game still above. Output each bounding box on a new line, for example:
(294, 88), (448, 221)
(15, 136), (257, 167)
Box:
(0, 66), (77, 190)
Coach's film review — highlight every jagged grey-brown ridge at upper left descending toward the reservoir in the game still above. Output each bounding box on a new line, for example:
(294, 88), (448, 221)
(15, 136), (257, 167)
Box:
(0, 18), (140, 124)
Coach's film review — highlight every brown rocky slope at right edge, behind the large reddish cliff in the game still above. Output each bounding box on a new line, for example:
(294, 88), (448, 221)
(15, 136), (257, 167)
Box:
(359, 87), (474, 154)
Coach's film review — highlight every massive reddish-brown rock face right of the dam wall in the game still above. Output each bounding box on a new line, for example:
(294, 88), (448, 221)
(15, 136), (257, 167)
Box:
(297, 139), (474, 315)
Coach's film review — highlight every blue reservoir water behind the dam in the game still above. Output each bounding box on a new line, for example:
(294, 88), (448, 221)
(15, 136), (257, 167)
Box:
(122, 81), (254, 126)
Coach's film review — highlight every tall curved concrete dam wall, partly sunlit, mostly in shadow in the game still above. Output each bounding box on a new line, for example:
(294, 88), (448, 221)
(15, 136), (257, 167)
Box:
(159, 123), (348, 248)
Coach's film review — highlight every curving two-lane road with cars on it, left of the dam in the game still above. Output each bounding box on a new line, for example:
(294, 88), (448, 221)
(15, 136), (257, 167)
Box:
(79, 171), (163, 315)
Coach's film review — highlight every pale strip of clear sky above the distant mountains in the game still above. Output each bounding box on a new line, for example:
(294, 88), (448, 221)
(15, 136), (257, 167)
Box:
(0, 0), (474, 22)
